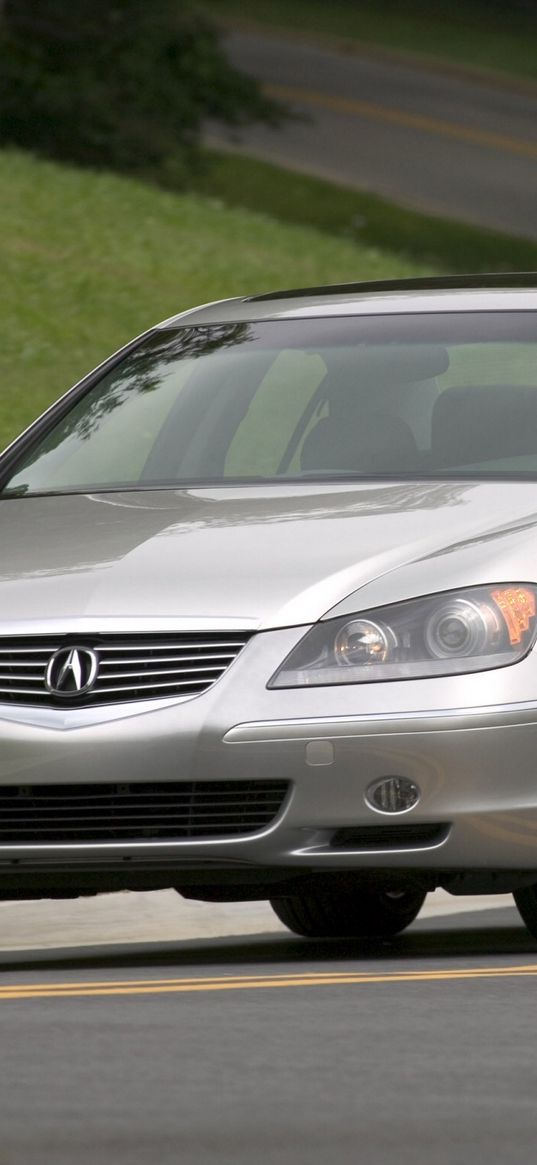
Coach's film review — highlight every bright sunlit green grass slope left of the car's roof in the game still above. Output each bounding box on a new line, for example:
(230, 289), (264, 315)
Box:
(0, 144), (431, 447)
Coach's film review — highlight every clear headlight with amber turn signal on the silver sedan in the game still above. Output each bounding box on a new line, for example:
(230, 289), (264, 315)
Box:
(268, 583), (537, 687)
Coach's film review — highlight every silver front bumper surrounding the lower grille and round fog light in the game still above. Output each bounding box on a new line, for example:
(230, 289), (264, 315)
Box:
(0, 628), (537, 896)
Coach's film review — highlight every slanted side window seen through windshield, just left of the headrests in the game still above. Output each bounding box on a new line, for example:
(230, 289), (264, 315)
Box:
(225, 350), (326, 478)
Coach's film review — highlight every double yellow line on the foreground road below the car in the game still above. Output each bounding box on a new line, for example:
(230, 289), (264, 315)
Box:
(0, 963), (537, 1002)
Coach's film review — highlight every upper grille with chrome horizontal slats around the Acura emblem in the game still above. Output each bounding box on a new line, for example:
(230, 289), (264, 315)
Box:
(0, 631), (252, 708)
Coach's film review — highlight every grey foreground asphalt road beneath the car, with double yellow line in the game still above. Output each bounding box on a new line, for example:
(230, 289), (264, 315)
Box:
(0, 908), (537, 1165)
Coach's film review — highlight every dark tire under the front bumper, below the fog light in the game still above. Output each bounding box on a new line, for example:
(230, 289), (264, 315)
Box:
(270, 888), (425, 939)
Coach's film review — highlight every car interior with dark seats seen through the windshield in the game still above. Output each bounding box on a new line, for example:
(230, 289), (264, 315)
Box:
(5, 333), (537, 493)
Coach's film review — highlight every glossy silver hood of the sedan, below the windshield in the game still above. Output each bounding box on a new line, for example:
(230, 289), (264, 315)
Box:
(0, 481), (537, 628)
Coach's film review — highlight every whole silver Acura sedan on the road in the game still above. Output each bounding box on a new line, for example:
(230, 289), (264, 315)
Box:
(0, 276), (537, 935)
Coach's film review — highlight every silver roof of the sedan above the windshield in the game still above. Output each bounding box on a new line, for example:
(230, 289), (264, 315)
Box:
(160, 271), (537, 327)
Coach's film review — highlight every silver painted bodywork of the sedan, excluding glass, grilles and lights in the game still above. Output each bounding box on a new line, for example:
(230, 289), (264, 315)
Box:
(0, 290), (537, 889)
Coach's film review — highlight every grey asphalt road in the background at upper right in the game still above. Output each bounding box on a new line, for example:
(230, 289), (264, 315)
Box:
(211, 31), (537, 239)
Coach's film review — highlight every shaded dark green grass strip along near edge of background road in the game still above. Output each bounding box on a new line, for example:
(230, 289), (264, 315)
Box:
(192, 151), (537, 273)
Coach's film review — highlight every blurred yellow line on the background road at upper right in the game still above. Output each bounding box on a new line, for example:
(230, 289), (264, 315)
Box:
(264, 85), (537, 157)
